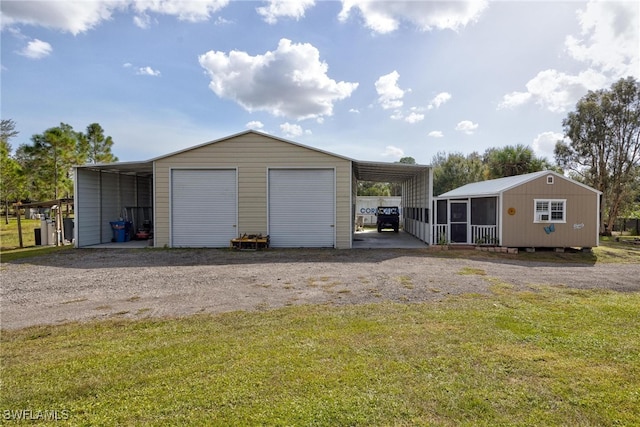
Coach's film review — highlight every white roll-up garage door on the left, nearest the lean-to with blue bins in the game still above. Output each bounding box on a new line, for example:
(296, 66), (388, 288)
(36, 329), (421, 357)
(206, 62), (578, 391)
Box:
(171, 169), (237, 248)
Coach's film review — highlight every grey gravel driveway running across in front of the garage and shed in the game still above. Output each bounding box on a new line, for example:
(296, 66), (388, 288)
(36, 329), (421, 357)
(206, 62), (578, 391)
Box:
(1, 249), (640, 329)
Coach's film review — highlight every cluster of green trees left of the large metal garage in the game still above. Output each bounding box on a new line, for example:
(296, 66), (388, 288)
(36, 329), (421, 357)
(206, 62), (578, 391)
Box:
(0, 119), (118, 219)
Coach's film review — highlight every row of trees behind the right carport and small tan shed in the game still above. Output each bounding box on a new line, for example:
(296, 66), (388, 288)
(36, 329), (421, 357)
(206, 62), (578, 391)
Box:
(358, 77), (640, 234)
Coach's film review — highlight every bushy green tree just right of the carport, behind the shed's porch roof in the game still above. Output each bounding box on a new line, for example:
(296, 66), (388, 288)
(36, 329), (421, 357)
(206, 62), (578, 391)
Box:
(431, 151), (485, 196)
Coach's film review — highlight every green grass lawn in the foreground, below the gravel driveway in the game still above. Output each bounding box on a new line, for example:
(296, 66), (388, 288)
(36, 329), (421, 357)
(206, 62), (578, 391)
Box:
(0, 284), (640, 426)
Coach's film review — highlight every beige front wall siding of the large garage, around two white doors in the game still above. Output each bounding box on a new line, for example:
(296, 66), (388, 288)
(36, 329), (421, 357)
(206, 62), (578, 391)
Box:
(154, 133), (352, 248)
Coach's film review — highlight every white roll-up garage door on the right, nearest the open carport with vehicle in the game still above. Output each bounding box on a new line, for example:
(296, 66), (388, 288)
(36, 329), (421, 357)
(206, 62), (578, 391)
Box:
(269, 169), (335, 248)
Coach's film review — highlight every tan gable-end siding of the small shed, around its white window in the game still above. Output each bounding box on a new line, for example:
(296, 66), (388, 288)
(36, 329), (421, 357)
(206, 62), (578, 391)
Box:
(501, 175), (599, 247)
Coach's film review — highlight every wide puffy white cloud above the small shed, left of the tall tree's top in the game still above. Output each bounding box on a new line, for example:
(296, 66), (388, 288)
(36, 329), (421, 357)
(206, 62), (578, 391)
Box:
(498, 70), (607, 113)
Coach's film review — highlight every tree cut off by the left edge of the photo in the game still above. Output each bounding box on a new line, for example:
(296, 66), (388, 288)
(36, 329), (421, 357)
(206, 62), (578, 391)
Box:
(0, 119), (22, 224)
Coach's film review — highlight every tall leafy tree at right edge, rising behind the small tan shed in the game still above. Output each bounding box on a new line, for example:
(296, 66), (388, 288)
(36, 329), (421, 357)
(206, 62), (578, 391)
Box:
(554, 77), (640, 234)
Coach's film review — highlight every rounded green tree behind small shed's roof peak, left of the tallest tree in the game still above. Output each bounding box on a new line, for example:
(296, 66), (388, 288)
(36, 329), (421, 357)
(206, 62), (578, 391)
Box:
(484, 144), (551, 179)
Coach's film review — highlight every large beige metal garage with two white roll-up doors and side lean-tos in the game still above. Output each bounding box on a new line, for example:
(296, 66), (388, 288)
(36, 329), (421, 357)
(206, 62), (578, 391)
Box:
(75, 130), (432, 249)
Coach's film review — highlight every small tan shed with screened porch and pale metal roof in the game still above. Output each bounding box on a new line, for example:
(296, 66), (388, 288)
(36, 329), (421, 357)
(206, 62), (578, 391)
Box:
(432, 171), (601, 248)
